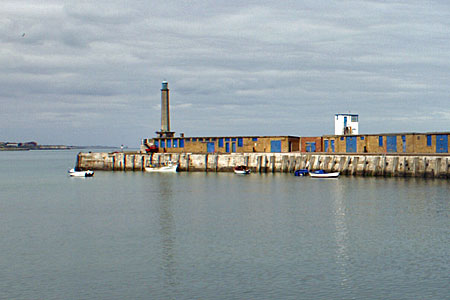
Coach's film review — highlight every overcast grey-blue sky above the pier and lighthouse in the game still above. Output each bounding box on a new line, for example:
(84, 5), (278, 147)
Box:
(0, 0), (450, 147)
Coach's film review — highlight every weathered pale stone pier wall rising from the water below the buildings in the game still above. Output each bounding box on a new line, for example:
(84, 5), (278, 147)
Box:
(77, 152), (450, 178)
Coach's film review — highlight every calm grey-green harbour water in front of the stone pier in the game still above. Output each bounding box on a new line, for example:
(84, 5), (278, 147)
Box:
(0, 151), (450, 300)
